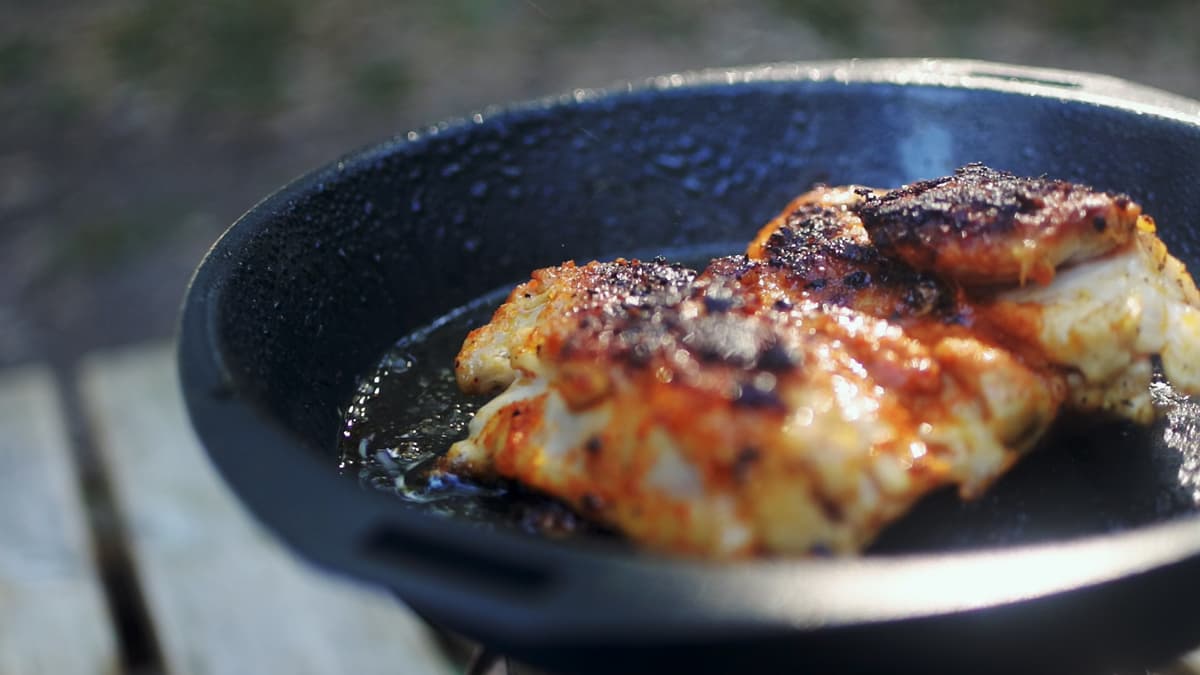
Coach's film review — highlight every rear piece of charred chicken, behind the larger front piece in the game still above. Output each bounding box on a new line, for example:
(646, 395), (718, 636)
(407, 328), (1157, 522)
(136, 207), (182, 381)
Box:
(748, 165), (1200, 423)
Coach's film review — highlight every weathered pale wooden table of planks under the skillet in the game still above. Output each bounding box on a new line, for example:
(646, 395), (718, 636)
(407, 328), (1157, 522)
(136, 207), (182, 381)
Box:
(0, 345), (1200, 675)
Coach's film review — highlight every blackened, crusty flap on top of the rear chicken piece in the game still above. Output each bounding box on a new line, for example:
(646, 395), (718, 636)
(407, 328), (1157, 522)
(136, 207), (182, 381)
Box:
(857, 163), (1141, 283)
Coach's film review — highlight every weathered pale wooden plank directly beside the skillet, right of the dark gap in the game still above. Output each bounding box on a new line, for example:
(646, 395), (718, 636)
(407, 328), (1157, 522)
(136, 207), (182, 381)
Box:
(80, 346), (451, 675)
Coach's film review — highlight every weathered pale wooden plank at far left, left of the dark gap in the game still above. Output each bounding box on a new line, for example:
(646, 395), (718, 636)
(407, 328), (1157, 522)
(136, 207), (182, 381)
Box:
(0, 366), (119, 675)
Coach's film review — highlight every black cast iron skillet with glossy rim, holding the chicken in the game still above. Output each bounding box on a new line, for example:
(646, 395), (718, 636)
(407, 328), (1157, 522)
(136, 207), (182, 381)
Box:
(179, 61), (1200, 673)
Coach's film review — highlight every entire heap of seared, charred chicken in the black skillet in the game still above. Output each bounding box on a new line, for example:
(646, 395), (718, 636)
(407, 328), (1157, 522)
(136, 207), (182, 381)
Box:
(442, 167), (1200, 556)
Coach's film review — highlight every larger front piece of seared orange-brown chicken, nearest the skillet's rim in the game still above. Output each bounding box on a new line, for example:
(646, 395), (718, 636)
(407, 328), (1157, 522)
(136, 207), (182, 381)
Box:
(443, 257), (1058, 556)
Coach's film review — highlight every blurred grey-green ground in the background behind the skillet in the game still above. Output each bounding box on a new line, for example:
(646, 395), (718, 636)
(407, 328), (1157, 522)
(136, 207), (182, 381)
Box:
(0, 0), (1200, 365)
